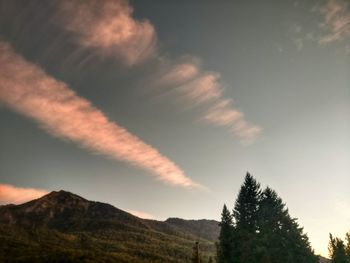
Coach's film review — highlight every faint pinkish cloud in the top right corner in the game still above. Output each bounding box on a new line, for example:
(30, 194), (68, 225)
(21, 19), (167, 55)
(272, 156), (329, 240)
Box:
(319, 0), (350, 44)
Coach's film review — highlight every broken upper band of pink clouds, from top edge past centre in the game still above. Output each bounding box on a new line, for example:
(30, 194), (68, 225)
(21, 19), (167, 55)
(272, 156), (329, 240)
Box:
(54, 0), (261, 142)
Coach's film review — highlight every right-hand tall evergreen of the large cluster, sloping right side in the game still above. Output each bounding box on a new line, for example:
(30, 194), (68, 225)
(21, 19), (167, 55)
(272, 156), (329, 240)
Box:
(258, 187), (318, 263)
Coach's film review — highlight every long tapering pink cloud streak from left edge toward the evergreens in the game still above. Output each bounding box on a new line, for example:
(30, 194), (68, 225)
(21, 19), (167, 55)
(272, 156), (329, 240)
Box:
(0, 42), (200, 190)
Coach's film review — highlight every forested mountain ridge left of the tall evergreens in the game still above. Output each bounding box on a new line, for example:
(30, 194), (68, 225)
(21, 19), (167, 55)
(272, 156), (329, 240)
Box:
(0, 191), (219, 262)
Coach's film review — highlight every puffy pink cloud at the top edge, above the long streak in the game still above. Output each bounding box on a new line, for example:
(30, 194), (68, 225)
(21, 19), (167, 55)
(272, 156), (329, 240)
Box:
(58, 0), (157, 65)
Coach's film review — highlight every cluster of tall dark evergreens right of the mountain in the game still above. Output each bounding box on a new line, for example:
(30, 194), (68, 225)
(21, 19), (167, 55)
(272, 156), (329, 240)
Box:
(217, 173), (318, 263)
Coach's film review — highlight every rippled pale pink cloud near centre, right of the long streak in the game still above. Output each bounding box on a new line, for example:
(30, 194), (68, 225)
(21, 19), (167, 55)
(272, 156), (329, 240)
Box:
(155, 58), (262, 144)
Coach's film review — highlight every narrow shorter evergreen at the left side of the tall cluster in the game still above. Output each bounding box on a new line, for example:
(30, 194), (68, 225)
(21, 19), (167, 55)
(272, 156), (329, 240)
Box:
(217, 205), (233, 263)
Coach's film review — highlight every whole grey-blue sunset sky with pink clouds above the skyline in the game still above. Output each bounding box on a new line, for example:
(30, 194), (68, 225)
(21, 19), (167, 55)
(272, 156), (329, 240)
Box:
(0, 0), (350, 256)
